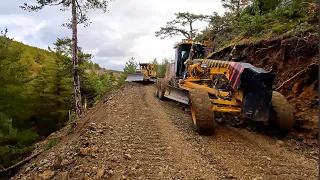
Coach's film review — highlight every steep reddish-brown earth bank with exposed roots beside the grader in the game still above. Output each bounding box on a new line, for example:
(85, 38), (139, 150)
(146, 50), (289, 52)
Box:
(211, 33), (319, 139)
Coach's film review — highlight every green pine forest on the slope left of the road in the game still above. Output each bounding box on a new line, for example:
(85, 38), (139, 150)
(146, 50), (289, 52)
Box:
(0, 36), (117, 170)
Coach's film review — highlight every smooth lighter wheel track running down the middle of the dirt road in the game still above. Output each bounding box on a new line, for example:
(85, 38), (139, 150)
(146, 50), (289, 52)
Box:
(146, 86), (221, 179)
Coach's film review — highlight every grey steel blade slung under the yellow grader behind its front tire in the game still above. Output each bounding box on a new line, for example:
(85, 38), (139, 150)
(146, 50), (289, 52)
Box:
(164, 86), (189, 104)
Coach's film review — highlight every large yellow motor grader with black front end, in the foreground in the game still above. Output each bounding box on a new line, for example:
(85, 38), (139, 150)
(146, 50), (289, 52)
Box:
(155, 39), (295, 135)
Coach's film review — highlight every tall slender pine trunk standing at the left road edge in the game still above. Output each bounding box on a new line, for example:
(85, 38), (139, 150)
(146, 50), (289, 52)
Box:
(71, 0), (82, 117)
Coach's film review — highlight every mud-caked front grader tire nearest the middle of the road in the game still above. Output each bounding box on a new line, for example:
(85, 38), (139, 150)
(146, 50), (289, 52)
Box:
(189, 89), (216, 135)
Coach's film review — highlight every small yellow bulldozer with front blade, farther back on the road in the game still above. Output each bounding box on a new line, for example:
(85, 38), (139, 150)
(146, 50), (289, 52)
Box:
(126, 63), (157, 82)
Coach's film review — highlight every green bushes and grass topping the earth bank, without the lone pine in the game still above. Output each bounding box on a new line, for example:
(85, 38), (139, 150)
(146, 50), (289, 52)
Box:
(197, 0), (319, 49)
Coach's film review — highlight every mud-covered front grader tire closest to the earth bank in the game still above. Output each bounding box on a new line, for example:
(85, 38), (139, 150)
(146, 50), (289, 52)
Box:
(268, 91), (295, 132)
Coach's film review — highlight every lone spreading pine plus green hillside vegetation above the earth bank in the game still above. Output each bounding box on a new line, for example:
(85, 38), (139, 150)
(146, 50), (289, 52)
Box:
(155, 0), (319, 50)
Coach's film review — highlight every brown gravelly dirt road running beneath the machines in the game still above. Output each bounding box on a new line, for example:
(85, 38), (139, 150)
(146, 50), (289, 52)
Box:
(12, 84), (318, 180)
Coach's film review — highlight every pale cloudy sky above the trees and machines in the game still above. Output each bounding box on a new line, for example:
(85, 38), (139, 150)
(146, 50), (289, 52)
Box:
(0, 0), (224, 70)
